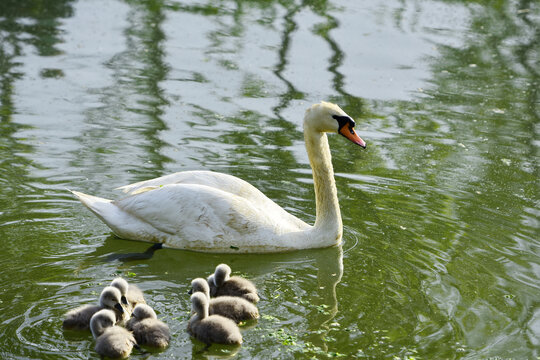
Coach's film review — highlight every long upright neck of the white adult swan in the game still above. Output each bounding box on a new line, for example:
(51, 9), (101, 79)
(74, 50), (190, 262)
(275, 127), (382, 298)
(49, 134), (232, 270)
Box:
(304, 125), (343, 241)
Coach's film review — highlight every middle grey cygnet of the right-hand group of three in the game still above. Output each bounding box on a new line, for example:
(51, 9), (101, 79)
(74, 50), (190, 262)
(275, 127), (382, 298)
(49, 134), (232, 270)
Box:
(189, 278), (259, 323)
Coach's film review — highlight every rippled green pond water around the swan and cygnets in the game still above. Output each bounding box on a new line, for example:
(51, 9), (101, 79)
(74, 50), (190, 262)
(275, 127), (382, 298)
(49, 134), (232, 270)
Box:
(0, 0), (540, 359)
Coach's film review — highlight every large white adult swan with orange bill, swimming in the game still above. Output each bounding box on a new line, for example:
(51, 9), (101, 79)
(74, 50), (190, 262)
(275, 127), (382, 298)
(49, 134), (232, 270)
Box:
(72, 102), (366, 253)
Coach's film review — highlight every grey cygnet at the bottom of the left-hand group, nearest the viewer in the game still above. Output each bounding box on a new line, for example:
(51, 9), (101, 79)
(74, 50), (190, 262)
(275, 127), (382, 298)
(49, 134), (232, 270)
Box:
(90, 309), (137, 359)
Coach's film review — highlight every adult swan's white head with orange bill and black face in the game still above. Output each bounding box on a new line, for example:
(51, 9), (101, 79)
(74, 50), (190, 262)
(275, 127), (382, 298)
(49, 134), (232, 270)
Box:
(304, 101), (366, 148)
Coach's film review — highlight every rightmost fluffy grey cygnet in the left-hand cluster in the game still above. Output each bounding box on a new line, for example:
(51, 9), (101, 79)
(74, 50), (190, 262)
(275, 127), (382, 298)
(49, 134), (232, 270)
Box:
(126, 304), (171, 348)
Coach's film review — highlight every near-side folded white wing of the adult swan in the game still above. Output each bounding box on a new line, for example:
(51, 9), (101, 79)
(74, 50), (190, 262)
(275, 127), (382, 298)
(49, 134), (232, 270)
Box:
(114, 184), (281, 248)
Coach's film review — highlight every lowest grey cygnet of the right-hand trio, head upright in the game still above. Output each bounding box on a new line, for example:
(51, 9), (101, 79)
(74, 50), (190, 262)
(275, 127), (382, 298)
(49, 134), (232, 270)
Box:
(187, 292), (242, 345)
